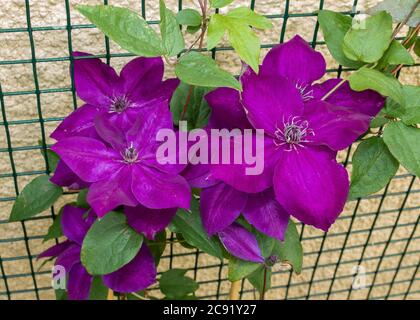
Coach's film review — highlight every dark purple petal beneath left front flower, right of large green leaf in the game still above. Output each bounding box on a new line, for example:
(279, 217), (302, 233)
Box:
(124, 204), (177, 240)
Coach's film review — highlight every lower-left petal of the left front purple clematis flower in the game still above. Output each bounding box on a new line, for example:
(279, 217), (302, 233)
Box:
(87, 165), (138, 217)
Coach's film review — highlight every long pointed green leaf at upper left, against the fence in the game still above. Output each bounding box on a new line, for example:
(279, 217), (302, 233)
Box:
(76, 5), (165, 57)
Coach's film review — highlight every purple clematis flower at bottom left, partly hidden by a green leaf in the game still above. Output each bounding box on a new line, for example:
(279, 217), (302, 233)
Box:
(38, 205), (156, 300)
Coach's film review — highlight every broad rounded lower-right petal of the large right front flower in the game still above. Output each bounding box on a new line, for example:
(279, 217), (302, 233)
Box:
(274, 147), (349, 231)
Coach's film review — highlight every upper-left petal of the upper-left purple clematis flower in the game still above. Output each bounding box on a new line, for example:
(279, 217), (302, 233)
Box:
(73, 52), (121, 107)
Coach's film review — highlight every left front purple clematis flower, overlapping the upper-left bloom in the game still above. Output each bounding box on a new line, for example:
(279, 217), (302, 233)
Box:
(51, 102), (190, 217)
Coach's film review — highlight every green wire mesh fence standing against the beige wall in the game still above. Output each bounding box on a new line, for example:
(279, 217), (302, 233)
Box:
(0, 0), (420, 300)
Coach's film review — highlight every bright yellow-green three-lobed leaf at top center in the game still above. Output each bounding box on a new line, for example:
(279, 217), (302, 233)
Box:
(207, 7), (272, 72)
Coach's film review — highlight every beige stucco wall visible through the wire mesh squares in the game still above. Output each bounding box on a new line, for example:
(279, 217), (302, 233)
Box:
(0, 0), (420, 299)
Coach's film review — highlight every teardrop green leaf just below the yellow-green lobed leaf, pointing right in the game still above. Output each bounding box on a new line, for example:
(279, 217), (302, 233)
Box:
(175, 51), (242, 90)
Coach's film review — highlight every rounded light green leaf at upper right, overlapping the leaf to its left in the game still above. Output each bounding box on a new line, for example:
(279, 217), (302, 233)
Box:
(343, 11), (392, 63)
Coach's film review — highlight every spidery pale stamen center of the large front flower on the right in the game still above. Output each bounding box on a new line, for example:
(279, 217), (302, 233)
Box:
(273, 117), (315, 151)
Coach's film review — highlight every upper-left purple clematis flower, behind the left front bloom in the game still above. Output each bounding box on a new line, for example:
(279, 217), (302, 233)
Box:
(51, 52), (179, 140)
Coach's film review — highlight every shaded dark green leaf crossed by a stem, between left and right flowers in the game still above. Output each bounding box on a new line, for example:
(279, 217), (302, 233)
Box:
(170, 82), (211, 130)
